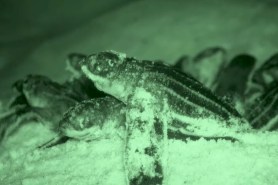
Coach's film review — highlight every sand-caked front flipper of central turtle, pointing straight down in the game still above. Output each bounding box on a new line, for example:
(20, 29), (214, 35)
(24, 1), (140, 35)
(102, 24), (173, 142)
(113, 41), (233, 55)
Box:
(125, 91), (167, 185)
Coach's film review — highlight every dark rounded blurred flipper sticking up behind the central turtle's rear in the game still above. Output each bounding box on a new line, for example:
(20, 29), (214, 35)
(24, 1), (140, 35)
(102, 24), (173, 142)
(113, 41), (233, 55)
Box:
(215, 54), (256, 99)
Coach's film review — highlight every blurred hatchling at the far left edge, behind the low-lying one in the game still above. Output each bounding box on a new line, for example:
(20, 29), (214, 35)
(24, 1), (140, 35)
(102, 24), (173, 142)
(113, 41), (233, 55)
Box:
(0, 75), (80, 141)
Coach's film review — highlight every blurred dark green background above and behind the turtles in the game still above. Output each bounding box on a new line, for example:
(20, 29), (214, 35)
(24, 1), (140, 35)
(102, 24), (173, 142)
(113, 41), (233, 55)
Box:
(0, 0), (278, 99)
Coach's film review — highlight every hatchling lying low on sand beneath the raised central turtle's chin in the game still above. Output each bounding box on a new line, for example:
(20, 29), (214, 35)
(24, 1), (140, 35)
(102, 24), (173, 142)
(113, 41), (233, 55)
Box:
(40, 96), (126, 148)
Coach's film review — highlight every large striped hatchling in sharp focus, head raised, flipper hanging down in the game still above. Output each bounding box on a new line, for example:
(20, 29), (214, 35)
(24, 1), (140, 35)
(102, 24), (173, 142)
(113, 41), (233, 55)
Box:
(80, 51), (249, 184)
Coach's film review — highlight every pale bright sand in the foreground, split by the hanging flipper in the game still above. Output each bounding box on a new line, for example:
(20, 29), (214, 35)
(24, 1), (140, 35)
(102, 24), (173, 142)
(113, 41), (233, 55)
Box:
(0, 124), (278, 185)
